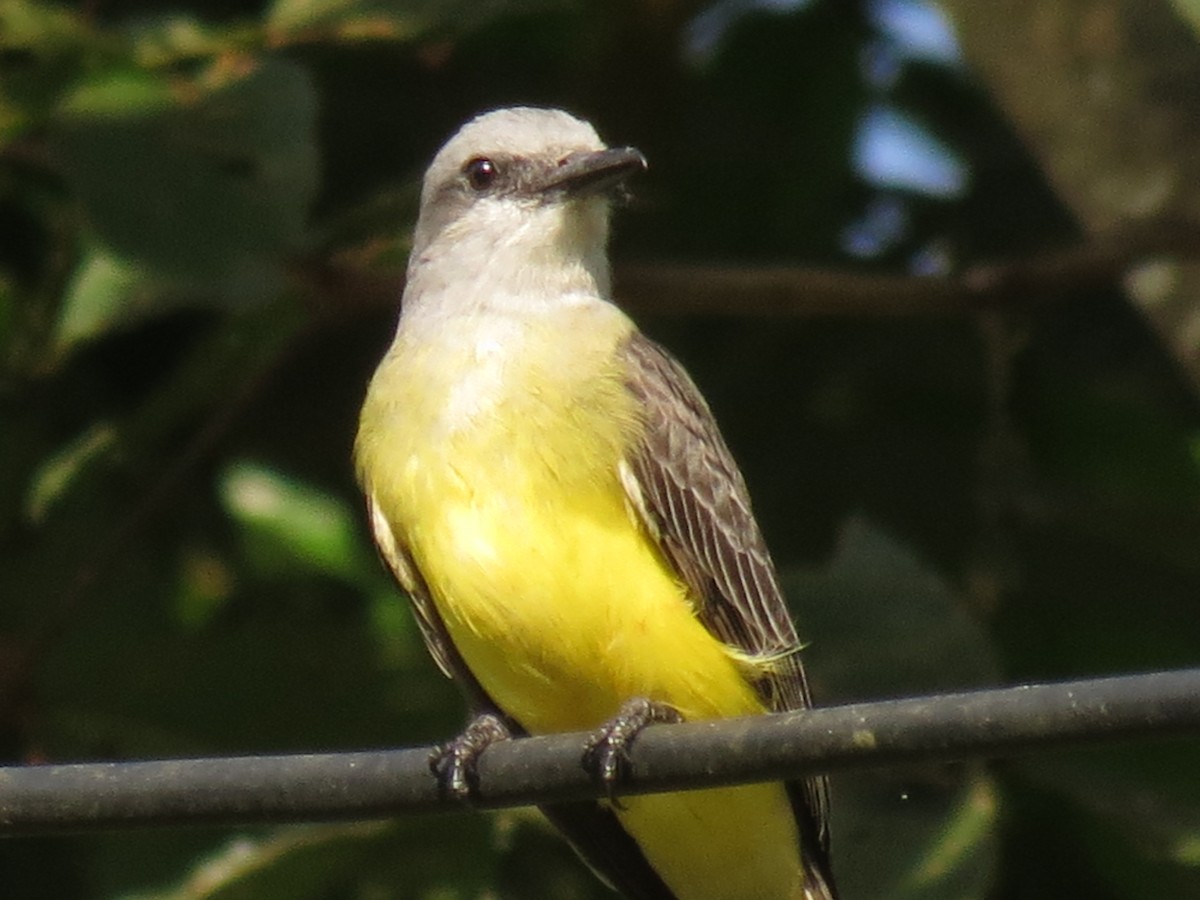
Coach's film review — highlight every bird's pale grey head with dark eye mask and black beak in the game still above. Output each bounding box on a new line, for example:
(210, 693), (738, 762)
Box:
(409, 107), (646, 300)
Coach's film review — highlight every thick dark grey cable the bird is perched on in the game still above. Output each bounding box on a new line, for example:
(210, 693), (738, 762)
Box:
(0, 668), (1200, 836)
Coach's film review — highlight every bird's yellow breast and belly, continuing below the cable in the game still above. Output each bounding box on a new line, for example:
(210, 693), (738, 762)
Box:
(356, 305), (802, 900)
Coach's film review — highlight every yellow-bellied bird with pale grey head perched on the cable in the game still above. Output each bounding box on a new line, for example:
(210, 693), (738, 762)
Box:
(354, 107), (835, 900)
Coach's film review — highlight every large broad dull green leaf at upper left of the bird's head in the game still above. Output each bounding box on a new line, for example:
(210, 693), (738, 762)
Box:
(56, 58), (317, 300)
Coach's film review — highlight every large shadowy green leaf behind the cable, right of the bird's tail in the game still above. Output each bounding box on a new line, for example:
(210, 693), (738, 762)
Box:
(784, 520), (1000, 900)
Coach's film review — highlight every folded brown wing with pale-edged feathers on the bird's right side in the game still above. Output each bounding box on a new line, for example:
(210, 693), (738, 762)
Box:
(624, 332), (828, 871)
